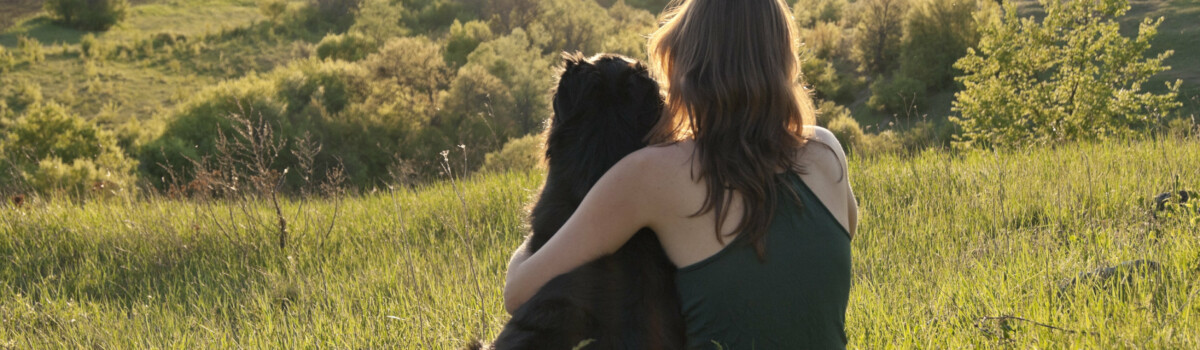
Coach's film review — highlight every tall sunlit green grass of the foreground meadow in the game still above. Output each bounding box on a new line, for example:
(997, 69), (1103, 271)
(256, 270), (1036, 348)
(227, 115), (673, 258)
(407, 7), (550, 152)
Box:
(0, 138), (1200, 349)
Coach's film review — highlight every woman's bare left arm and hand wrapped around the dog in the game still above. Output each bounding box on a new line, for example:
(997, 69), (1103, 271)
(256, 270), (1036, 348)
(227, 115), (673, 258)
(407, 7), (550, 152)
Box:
(504, 151), (662, 314)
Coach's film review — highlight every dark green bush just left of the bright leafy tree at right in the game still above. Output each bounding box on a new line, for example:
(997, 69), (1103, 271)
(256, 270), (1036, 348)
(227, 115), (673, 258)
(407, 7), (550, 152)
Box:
(900, 0), (1000, 90)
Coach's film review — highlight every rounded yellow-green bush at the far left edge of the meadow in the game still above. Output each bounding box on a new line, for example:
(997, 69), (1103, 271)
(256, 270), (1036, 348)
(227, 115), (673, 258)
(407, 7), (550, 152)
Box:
(0, 103), (137, 194)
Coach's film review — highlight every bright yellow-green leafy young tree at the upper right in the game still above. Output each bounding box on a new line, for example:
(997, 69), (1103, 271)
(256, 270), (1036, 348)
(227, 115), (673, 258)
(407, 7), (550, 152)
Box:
(952, 0), (1182, 147)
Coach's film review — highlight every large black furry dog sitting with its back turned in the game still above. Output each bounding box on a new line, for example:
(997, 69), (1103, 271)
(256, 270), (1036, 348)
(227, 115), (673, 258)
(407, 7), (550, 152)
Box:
(493, 54), (684, 349)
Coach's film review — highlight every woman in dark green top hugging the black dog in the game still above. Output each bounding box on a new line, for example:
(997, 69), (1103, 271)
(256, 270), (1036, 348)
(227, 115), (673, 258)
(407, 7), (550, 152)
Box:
(504, 0), (857, 349)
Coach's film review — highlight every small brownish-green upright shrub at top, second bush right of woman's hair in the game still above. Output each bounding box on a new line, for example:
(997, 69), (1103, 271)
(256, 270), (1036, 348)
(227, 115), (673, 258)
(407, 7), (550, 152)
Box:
(851, 0), (908, 76)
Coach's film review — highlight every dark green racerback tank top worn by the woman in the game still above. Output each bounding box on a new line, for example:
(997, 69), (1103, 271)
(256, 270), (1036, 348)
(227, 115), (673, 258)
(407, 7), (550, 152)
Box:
(676, 171), (851, 349)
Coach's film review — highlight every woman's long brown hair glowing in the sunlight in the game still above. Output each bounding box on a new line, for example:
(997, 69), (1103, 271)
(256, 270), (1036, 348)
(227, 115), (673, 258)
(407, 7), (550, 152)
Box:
(648, 0), (815, 258)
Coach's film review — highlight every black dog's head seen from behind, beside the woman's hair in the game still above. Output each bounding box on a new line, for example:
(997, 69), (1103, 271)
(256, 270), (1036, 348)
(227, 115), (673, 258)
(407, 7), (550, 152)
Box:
(546, 53), (662, 193)
